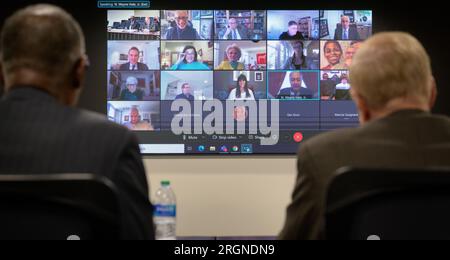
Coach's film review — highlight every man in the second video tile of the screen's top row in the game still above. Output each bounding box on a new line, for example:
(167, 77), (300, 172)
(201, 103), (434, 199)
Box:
(166, 10), (202, 40)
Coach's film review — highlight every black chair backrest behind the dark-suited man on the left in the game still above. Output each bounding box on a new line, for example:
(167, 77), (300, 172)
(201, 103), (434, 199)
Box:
(0, 174), (120, 240)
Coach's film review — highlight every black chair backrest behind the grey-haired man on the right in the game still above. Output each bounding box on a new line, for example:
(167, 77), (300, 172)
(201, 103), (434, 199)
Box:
(326, 168), (450, 240)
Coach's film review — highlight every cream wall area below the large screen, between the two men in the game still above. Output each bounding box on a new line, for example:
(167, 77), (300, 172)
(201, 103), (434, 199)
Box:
(144, 156), (296, 236)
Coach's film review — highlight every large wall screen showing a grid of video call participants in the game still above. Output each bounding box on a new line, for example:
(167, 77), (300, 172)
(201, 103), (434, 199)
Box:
(106, 9), (372, 155)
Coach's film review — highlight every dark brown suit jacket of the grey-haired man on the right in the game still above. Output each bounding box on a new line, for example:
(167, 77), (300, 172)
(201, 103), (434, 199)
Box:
(280, 111), (450, 239)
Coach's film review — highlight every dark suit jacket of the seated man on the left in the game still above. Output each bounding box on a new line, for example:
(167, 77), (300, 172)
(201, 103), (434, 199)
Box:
(0, 88), (154, 239)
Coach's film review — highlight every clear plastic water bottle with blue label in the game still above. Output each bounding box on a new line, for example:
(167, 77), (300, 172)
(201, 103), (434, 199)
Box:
(154, 181), (177, 240)
